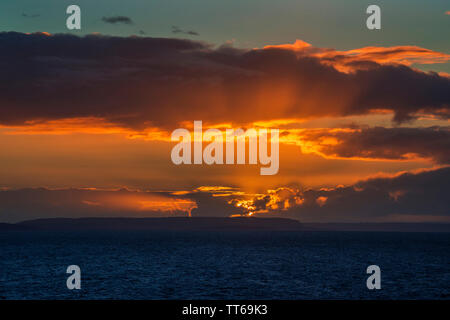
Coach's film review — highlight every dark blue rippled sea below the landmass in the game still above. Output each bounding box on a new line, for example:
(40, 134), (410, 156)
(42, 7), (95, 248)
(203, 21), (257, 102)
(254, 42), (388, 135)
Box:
(0, 232), (450, 299)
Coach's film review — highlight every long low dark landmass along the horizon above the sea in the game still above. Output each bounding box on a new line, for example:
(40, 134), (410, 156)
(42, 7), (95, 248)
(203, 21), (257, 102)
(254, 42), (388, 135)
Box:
(0, 217), (450, 232)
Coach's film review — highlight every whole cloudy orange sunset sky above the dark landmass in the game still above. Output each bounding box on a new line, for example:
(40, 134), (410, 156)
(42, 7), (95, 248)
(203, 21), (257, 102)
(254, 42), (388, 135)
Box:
(0, 0), (450, 222)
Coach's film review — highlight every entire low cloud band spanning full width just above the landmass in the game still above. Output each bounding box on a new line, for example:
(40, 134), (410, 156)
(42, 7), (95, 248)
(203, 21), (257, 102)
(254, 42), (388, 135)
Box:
(0, 167), (450, 222)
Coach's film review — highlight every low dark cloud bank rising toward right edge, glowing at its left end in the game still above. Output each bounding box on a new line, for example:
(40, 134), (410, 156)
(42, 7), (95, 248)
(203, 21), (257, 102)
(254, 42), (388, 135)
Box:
(232, 167), (450, 222)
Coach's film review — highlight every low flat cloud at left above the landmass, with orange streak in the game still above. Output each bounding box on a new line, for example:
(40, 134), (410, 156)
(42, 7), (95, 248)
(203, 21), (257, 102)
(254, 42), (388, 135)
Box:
(0, 188), (195, 222)
